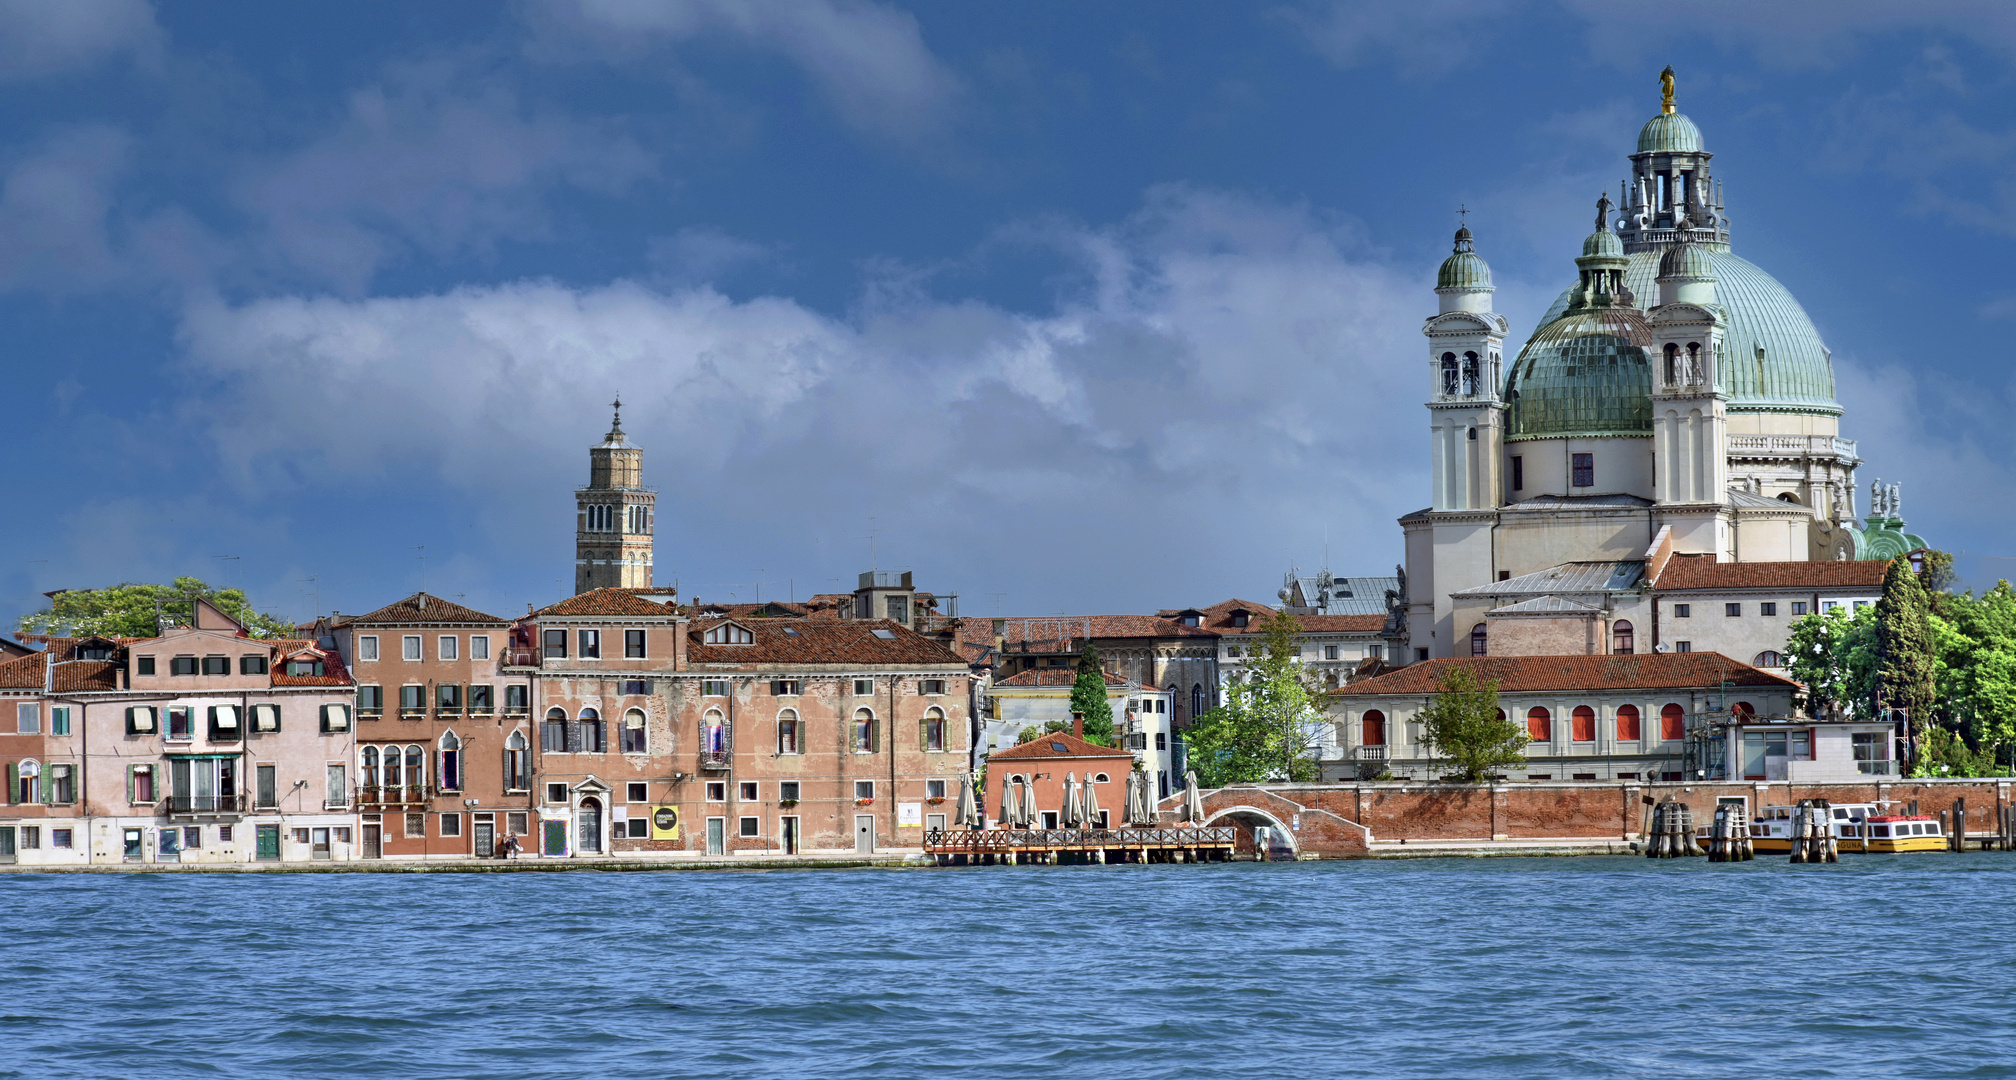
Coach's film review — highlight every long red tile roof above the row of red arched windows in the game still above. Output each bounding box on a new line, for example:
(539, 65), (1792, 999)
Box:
(1331, 653), (1798, 697)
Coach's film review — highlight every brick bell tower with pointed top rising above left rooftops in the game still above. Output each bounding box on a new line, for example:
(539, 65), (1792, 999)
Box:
(575, 397), (657, 594)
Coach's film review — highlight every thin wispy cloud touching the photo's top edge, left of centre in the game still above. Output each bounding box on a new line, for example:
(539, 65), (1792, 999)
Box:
(530, 0), (962, 143)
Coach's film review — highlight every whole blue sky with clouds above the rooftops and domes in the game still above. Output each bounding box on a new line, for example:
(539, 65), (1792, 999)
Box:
(0, 0), (2016, 623)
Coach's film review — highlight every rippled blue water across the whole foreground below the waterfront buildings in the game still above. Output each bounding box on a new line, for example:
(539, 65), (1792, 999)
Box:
(0, 852), (2016, 1080)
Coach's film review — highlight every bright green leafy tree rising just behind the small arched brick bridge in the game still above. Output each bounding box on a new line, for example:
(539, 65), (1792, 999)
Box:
(1183, 613), (1327, 788)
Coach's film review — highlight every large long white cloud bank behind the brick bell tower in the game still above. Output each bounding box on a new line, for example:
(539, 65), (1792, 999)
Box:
(183, 189), (1433, 604)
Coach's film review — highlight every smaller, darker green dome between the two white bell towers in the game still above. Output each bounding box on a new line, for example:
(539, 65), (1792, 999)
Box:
(1506, 304), (1651, 439)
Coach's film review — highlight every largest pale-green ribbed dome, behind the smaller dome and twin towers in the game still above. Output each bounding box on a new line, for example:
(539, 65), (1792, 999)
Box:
(1534, 244), (1841, 417)
